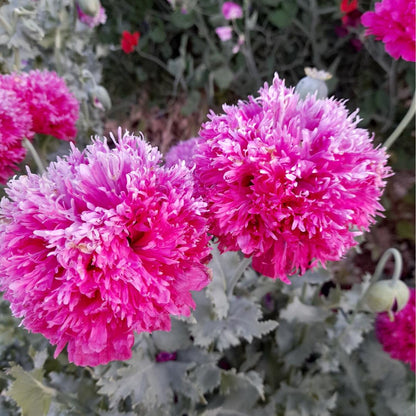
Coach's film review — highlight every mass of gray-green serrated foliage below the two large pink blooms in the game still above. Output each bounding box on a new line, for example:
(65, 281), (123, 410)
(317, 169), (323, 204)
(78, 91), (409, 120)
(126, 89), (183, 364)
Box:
(0, 245), (414, 416)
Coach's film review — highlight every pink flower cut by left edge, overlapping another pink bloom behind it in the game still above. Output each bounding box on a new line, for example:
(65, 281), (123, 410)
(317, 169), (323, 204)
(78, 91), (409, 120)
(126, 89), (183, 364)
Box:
(0, 89), (32, 183)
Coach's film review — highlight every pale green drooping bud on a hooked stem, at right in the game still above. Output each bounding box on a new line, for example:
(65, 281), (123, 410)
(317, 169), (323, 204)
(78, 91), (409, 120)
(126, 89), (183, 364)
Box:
(365, 280), (410, 316)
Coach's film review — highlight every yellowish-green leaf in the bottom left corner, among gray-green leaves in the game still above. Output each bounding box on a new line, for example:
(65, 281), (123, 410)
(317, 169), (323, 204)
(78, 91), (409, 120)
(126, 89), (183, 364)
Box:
(7, 366), (56, 416)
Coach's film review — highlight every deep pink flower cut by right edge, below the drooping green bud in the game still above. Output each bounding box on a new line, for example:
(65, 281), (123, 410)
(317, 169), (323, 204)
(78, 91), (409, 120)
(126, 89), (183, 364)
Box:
(375, 289), (416, 371)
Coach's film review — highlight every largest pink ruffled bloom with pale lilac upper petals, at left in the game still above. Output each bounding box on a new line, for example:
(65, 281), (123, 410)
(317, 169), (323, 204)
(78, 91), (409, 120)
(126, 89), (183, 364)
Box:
(0, 130), (210, 365)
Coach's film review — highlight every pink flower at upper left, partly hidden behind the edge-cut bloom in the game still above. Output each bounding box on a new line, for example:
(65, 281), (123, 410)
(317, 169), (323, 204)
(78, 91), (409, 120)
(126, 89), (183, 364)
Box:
(0, 70), (79, 140)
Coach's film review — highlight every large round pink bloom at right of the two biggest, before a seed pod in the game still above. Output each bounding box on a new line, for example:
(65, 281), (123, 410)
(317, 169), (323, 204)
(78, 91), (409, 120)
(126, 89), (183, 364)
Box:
(194, 75), (390, 283)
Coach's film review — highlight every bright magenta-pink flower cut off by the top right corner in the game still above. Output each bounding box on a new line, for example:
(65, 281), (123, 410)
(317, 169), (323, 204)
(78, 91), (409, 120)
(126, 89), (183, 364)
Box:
(361, 0), (416, 62)
